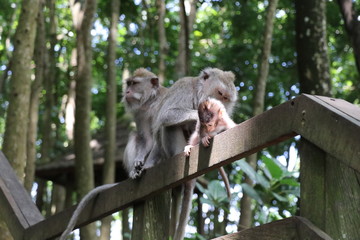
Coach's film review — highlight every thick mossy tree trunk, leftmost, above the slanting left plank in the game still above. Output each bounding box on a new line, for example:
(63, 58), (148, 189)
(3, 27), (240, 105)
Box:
(0, 0), (40, 240)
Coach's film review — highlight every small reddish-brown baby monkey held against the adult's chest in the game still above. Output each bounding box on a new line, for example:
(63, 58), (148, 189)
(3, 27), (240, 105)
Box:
(184, 98), (236, 156)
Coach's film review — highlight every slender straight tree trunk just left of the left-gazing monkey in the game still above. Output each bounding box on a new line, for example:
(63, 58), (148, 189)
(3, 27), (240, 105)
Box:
(100, 0), (120, 240)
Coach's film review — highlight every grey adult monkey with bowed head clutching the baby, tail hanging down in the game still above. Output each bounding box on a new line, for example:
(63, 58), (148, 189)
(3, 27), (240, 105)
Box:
(142, 68), (237, 240)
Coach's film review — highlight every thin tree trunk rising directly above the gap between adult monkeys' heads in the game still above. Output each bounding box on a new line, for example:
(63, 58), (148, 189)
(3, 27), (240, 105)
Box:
(156, 0), (169, 84)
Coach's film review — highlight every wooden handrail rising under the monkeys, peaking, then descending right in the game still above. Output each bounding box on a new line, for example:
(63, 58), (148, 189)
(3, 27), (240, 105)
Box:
(1, 95), (360, 240)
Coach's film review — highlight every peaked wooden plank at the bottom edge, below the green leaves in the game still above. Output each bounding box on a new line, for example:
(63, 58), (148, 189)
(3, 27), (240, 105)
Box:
(213, 217), (332, 240)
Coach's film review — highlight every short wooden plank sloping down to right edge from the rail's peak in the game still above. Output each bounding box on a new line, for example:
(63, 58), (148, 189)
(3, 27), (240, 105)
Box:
(294, 94), (360, 172)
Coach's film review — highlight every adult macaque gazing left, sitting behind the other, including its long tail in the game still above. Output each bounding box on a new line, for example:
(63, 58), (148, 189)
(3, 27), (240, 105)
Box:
(60, 68), (166, 240)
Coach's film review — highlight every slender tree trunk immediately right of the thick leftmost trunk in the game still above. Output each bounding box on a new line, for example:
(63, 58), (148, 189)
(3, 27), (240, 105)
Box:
(24, 2), (46, 193)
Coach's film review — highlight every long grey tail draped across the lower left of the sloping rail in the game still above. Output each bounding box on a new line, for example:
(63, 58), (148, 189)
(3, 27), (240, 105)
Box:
(59, 183), (117, 240)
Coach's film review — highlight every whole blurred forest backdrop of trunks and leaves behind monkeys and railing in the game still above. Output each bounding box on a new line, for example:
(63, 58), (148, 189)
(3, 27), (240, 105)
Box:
(0, 0), (360, 239)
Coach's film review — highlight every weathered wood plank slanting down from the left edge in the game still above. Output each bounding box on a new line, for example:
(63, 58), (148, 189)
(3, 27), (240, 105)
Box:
(0, 151), (44, 239)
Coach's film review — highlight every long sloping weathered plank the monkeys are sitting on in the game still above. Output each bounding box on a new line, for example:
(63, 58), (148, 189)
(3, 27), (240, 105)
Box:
(25, 94), (296, 240)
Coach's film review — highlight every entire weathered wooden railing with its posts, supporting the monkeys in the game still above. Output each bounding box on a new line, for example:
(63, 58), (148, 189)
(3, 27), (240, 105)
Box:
(0, 95), (360, 240)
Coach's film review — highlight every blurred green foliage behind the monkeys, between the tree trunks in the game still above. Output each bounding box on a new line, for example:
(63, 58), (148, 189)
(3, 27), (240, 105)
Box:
(0, 0), (360, 239)
